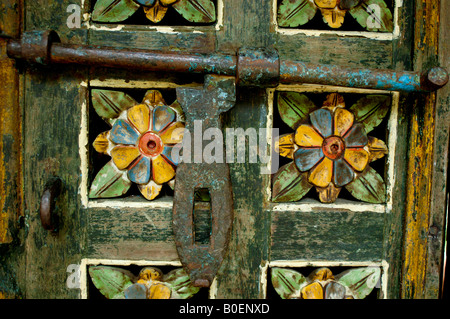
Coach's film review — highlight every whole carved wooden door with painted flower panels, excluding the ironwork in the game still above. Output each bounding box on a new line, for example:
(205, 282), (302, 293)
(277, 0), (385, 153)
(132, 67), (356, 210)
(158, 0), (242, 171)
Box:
(0, 0), (450, 299)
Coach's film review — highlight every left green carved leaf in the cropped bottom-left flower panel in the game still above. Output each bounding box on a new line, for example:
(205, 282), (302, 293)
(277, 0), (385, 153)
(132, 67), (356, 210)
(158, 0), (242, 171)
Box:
(89, 266), (135, 299)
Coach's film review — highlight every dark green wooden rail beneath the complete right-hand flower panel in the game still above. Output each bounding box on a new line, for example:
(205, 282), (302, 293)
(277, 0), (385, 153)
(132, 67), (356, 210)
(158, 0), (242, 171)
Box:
(270, 209), (384, 261)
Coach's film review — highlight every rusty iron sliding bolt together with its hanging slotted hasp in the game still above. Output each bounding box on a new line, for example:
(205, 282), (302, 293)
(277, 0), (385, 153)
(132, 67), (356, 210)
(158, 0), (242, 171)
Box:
(7, 31), (449, 287)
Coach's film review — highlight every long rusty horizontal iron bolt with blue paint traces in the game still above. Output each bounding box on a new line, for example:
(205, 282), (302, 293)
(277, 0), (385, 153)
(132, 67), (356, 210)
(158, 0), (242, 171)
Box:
(7, 31), (449, 92)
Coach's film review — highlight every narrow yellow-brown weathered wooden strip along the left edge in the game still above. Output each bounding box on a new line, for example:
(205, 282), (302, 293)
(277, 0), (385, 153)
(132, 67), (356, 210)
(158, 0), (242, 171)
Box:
(0, 0), (25, 299)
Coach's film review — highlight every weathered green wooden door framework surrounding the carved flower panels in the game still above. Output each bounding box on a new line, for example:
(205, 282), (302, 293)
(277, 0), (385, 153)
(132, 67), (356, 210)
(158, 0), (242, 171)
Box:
(0, 0), (449, 298)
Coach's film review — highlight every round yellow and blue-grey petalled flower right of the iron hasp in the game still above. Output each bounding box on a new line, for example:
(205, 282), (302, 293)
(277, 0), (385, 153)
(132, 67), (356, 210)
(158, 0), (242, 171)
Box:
(294, 101), (369, 188)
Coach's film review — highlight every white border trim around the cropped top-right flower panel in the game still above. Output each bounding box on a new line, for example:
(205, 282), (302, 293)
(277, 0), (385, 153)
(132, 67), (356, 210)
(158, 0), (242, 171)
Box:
(272, 0), (403, 40)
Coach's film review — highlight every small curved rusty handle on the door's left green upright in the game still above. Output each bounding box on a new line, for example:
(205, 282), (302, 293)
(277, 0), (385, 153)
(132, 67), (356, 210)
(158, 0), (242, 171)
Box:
(40, 177), (62, 232)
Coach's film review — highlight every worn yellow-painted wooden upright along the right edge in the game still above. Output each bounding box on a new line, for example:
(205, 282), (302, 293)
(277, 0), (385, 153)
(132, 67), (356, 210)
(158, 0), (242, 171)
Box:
(402, 1), (449, 298)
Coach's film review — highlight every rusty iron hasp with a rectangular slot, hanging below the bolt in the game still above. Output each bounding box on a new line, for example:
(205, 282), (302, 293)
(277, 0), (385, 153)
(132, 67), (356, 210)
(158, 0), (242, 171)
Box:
(172, 75), (236, 287)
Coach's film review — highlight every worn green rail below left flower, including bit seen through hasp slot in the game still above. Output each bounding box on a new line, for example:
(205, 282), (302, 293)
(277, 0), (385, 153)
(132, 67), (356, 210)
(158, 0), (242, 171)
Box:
(85, 198), (211, 261)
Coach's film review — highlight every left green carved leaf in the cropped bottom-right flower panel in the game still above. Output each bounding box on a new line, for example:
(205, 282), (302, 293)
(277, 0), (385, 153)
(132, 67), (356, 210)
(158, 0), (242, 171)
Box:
(272, 268), (307, 299)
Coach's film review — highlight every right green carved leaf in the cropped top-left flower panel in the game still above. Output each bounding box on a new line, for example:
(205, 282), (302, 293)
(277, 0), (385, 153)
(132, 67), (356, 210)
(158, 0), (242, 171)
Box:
(172, 0), (216, 23)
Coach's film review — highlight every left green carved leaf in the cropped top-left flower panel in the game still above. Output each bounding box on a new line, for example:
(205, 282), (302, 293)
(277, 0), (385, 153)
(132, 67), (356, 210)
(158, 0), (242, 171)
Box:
(92, 0), (140, 22)
